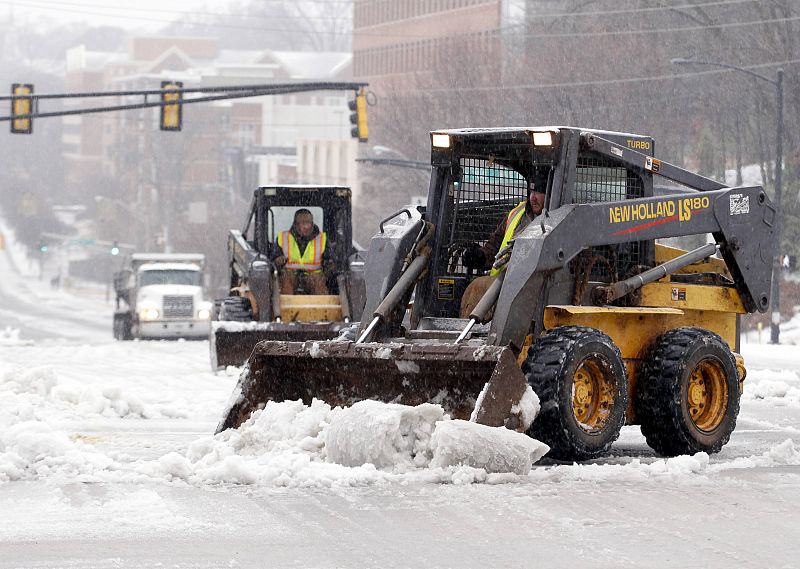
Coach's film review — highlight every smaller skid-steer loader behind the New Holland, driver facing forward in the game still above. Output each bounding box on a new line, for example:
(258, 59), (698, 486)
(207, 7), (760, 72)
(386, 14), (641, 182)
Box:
(210, 184), (364, 370)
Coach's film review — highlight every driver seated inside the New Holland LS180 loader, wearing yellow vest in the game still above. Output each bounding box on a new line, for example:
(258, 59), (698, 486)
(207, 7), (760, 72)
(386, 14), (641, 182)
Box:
(459, 182), (545, 318)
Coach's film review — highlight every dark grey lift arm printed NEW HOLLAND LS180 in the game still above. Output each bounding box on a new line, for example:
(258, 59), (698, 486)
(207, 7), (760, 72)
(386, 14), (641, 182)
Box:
(490, 184), (776, 349)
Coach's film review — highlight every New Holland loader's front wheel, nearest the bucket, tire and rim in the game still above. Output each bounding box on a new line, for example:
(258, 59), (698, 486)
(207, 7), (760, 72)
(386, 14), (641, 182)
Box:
(522, 326), (628, 461)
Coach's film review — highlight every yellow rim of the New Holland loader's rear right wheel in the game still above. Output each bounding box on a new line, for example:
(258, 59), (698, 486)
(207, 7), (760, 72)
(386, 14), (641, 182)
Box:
(686, 359), (729, 432)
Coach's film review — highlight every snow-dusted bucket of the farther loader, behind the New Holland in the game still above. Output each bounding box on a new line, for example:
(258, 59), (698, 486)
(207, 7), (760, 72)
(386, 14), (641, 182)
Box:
(209, 322), (341, 371)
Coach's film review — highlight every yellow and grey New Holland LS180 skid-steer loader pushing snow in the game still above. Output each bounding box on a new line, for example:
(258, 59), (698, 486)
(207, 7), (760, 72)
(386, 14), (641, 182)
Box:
(218, 127), (777, 460)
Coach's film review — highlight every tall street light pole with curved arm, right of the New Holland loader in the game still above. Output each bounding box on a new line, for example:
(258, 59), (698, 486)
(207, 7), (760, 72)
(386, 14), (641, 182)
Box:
(671, 58), (783, 344)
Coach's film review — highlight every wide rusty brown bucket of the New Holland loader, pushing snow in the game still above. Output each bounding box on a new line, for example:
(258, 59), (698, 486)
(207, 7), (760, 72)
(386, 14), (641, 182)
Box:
(217, 341), (527, 432)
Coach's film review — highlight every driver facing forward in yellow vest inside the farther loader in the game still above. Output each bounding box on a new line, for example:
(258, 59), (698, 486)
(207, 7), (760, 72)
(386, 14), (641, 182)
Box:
(273, 208), (331, 294)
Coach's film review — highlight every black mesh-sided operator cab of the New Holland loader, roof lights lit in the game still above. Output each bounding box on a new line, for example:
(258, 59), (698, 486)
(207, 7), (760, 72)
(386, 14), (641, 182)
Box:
(417, 127), (654, 318)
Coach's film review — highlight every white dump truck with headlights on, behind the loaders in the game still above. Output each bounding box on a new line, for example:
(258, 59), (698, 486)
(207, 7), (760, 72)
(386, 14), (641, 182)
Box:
(114, 253), (213, 340)
